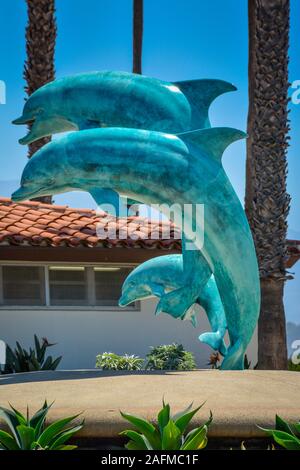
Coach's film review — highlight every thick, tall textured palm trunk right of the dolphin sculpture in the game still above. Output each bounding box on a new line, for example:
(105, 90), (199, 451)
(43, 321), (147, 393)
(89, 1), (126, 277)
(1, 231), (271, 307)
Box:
(245, 0), (290, 369)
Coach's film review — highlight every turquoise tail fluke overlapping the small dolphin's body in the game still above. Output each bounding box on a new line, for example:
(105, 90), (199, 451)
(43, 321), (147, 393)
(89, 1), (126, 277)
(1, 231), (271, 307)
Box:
(155, 286), (196, 320)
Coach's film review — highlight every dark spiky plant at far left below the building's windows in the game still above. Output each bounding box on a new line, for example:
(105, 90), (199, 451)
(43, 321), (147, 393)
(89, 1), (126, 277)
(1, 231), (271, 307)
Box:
(0, 335), (62, 374)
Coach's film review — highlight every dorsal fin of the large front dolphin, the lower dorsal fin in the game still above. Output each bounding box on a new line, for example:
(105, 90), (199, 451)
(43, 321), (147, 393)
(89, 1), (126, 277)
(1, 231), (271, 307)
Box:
(176, 127), (247, 163)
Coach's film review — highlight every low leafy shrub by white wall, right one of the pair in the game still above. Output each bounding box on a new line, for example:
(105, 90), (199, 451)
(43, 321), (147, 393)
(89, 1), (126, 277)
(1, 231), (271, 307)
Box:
(146, 343), (196, 370)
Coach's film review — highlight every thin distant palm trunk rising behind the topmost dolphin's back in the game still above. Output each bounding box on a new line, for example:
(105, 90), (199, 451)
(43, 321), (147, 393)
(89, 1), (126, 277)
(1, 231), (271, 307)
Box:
(132, 0), (143, 74)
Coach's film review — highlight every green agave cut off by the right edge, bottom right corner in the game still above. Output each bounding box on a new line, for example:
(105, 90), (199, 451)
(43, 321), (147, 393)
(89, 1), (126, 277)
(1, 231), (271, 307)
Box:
(259, 415), (300, 450)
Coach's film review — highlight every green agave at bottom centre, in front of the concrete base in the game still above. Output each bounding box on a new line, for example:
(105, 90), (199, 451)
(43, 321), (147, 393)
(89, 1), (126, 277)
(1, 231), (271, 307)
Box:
(120, 401), (212, 450)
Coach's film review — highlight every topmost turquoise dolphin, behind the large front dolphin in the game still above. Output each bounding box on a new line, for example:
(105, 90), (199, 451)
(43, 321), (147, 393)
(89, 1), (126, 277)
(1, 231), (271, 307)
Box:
(13, 71), (236, 144)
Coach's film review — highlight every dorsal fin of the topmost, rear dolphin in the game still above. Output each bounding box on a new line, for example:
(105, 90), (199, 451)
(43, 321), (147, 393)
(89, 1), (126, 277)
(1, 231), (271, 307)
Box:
(174, 79), (236, 129)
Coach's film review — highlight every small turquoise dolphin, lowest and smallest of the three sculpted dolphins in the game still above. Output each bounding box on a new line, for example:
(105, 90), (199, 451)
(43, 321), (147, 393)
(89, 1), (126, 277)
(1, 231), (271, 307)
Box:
(119, 254), (227, 356)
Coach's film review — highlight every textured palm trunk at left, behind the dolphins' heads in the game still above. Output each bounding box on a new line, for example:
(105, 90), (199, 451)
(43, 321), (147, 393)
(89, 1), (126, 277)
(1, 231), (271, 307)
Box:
(24, 0), (56, 202)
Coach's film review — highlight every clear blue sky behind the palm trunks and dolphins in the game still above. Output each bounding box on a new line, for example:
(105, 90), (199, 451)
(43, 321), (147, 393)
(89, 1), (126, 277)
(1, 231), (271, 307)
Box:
(0, 0), (300, 323)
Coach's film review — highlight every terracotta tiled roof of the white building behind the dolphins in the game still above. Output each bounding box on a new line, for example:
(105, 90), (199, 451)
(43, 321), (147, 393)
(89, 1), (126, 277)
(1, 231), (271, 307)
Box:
(0, 197), (300, 268)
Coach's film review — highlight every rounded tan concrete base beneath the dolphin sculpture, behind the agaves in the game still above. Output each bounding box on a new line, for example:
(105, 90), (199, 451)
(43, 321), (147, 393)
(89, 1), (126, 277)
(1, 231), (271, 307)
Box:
(0, 370), (300, 438)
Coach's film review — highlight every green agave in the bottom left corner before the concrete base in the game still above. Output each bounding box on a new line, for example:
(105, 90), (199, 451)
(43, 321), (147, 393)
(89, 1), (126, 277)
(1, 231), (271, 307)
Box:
(0, 401), (83, 450)
